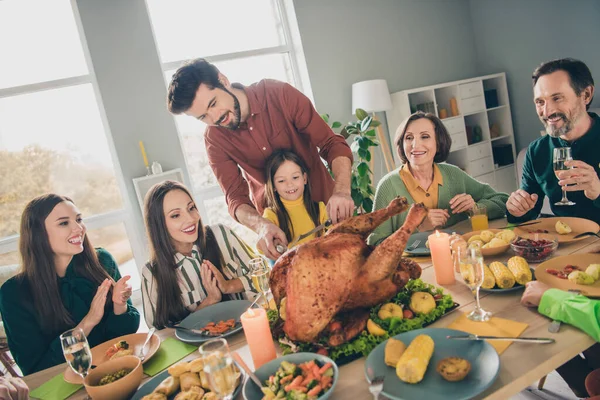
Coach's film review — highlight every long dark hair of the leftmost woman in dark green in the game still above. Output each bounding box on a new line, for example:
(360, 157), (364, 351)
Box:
(18, 193), (112, 334)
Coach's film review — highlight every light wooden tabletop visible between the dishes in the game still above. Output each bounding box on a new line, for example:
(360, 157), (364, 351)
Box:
(24, 220), (600, 400)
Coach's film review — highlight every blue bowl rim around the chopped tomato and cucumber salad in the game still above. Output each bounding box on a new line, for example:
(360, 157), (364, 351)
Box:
(242, 353), (340, 400)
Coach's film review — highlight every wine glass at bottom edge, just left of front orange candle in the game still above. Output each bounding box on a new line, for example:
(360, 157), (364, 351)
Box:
(198, 339), (237, 400)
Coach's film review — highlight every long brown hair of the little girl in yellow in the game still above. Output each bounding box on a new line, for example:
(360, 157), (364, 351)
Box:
(265, 149), (321, 242)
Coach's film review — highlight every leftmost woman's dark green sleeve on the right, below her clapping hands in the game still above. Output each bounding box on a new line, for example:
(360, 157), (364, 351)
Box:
(96, 248), (140, 337)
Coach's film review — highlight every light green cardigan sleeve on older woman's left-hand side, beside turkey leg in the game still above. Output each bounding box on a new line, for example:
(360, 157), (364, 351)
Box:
(367, 170), (409, 246)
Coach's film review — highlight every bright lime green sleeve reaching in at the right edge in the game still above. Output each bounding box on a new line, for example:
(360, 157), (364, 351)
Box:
(538, 289), (600, 342)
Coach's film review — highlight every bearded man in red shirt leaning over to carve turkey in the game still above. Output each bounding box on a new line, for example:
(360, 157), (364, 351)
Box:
(167, 59), (354, 259)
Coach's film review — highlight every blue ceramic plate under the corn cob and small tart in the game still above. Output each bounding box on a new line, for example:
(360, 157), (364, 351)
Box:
(365, 328), (500, 400)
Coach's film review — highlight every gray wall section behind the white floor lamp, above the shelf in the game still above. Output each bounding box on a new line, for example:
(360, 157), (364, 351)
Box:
(294, 0), (477, 182)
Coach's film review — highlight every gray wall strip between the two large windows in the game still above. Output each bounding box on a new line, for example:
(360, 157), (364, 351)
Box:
(77, 0), (189, 253)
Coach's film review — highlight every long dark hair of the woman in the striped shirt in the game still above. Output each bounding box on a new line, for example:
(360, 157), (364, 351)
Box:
(144, 180), (223, 329)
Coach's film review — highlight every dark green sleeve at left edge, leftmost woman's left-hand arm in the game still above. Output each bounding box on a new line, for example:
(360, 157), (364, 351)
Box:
(0, 278), (65, 375)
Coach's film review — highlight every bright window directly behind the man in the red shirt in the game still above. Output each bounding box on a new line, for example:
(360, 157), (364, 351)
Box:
(146, 0), (310, 245)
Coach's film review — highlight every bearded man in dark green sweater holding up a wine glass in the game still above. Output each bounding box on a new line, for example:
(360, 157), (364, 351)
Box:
(506, 58), (600, 223)
